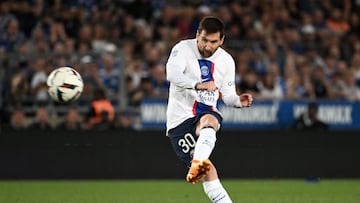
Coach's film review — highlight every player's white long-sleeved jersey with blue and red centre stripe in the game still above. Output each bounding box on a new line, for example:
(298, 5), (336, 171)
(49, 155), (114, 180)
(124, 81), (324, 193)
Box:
(166, 39), (241, 131)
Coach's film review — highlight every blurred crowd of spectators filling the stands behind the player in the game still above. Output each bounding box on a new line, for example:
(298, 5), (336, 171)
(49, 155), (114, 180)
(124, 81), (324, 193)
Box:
(0, 0), (360, 129)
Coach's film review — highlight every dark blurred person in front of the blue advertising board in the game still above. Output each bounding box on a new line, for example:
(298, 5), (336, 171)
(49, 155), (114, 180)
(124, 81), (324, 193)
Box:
(293, 102), (329, 131)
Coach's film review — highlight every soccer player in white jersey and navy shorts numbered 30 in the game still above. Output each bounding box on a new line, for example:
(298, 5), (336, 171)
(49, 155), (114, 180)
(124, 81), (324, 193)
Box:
(166, 16), (253, 203)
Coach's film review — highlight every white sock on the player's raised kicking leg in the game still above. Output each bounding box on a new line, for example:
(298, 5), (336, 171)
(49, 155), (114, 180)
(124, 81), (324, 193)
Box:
(193, 128), (216, 160)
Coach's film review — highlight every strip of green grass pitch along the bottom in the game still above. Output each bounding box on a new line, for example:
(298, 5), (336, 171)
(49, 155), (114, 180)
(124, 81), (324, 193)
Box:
(0, 179), (360, 203)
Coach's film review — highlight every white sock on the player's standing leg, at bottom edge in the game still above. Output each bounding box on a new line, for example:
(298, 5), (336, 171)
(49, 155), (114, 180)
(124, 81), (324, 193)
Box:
(203, 179), (232, 203)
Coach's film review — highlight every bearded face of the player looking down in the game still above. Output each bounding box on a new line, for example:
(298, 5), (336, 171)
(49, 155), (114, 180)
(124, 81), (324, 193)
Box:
(196, 30), (224, 58)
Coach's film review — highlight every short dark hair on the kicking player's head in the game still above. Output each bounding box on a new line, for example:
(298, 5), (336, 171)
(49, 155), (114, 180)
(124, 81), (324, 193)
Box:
(198, 16), (225, 38)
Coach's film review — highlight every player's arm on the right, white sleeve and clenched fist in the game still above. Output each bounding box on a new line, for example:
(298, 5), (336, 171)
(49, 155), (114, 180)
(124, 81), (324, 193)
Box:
(220, 56), (253, 108)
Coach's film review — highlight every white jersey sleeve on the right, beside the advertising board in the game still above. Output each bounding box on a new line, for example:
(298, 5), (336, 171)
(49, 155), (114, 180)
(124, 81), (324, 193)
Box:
(220, 57), (242, 108)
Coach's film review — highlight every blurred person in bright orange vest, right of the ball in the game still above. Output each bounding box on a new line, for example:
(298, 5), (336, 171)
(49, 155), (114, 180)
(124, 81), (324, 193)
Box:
(85, 89), (115, 130)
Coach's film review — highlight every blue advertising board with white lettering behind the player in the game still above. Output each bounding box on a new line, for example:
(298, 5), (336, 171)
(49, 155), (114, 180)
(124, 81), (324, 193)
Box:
(141, 100), (360, 130)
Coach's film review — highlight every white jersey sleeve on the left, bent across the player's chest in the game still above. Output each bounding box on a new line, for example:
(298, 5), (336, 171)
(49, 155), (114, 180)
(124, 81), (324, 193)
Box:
(166, 44), (197, 89)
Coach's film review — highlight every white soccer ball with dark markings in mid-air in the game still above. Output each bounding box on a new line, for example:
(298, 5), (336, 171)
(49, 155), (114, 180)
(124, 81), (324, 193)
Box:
(46, 67), (84, 103)
